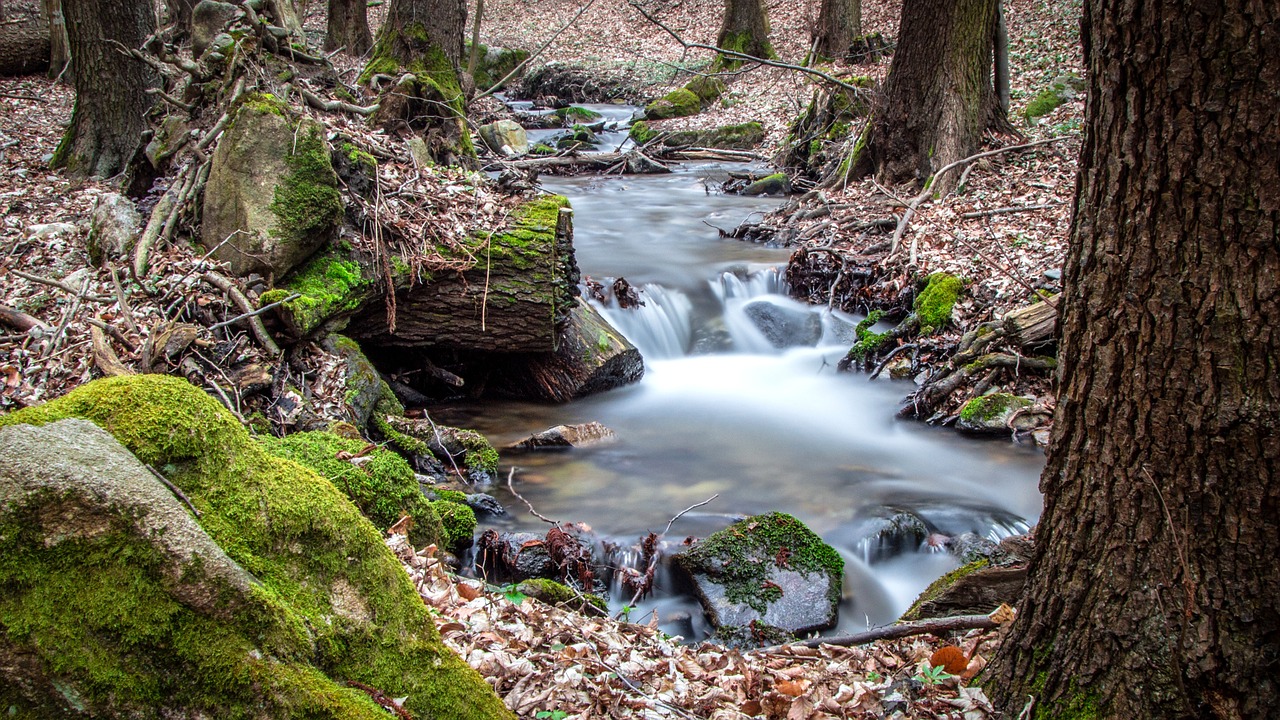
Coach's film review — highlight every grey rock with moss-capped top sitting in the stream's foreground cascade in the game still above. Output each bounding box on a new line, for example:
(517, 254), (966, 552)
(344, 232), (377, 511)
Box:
(676, 512), (845, 633)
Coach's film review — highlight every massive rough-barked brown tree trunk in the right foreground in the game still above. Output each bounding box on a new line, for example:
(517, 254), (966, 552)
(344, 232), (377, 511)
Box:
(986, 0), (1280, 719)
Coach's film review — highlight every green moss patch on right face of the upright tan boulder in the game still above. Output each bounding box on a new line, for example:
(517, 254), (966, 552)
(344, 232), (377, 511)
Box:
(270, 123), (343, 247)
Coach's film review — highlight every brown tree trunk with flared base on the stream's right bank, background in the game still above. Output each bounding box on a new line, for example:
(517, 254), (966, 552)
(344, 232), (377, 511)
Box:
(854, 0), (1000, 192)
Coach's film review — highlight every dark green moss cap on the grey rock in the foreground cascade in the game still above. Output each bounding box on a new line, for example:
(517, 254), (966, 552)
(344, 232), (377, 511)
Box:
(678, 512), (845, 614)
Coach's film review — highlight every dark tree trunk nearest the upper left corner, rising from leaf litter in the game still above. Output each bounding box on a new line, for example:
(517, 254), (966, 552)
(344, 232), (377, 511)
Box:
(52, 0), (157, 177)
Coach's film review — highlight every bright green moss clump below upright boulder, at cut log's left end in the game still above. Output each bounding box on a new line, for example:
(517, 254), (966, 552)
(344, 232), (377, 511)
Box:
(259, 249), (372, 337)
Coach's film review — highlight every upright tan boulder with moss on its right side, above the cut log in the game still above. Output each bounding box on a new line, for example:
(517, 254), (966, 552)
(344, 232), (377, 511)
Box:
(201, 94), (343, 277)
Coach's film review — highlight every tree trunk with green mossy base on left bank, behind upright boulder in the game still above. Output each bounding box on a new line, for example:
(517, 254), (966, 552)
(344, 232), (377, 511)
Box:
(361, 0), (475, 164)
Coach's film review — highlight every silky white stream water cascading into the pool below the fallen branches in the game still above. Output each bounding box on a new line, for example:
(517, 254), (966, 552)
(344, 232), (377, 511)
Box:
(445, 159), (1043, 638)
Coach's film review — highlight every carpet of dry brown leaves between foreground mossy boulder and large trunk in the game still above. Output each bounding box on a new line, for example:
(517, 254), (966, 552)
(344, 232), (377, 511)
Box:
(388, 536), (996, 720)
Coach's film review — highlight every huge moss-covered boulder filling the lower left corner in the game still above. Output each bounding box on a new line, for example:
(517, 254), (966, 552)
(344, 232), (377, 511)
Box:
(0, 375), (511, 720)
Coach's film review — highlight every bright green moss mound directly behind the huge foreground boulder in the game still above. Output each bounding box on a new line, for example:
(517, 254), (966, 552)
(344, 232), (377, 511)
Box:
(260, 432), (448, 547)
